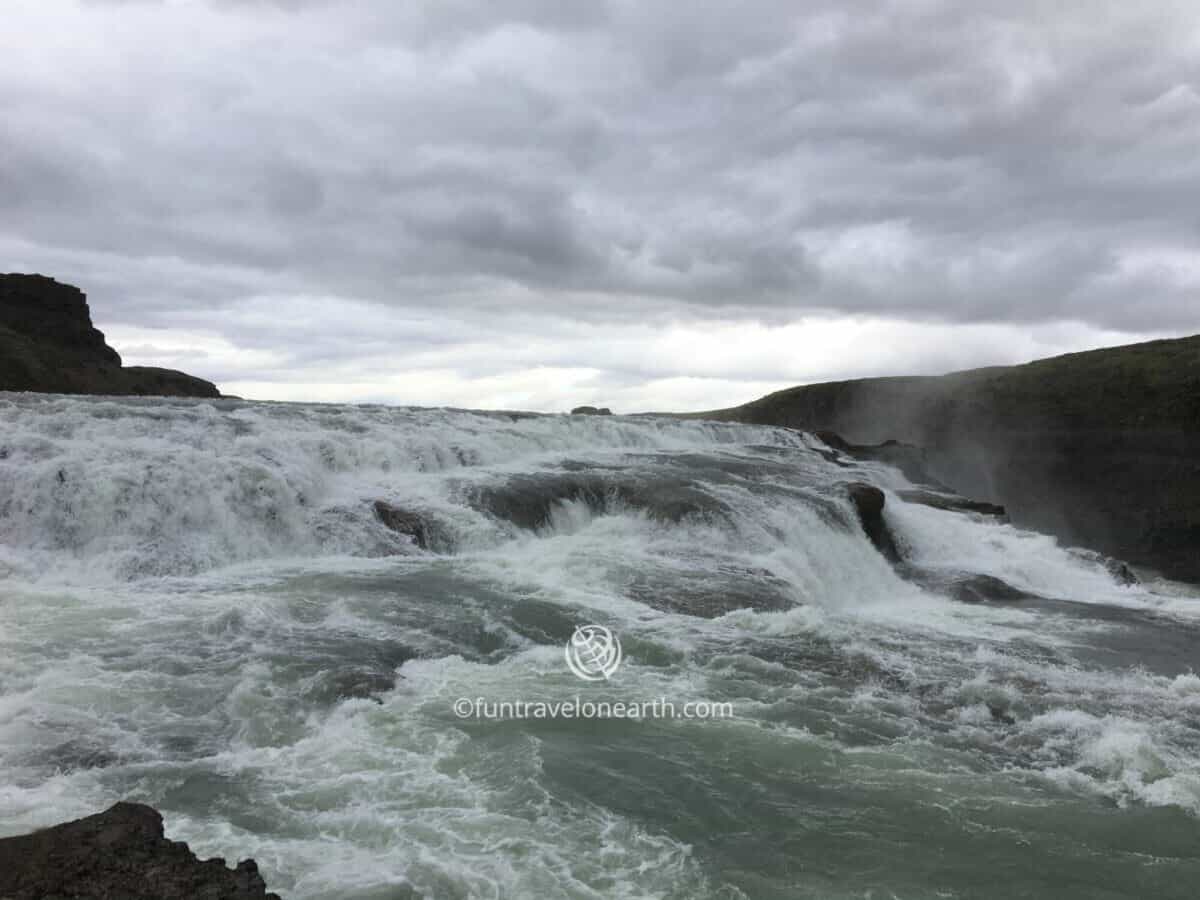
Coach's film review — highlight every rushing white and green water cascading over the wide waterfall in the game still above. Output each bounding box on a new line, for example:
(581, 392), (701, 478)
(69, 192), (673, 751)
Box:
(0, 395), (1200, 900)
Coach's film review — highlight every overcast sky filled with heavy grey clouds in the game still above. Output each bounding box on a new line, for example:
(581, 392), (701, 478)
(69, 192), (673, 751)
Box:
(0, 0), (1200, 412)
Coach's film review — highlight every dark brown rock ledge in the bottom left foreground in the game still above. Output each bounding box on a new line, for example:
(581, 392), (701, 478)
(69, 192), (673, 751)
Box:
(0, 803), (280, 900)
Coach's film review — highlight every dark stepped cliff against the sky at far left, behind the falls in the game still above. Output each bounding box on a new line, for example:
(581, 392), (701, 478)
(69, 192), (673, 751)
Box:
(0, 275), (221, 397)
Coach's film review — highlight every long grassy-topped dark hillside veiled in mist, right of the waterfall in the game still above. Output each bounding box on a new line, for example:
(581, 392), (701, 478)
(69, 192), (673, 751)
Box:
(698, 336), (1200, 582)
